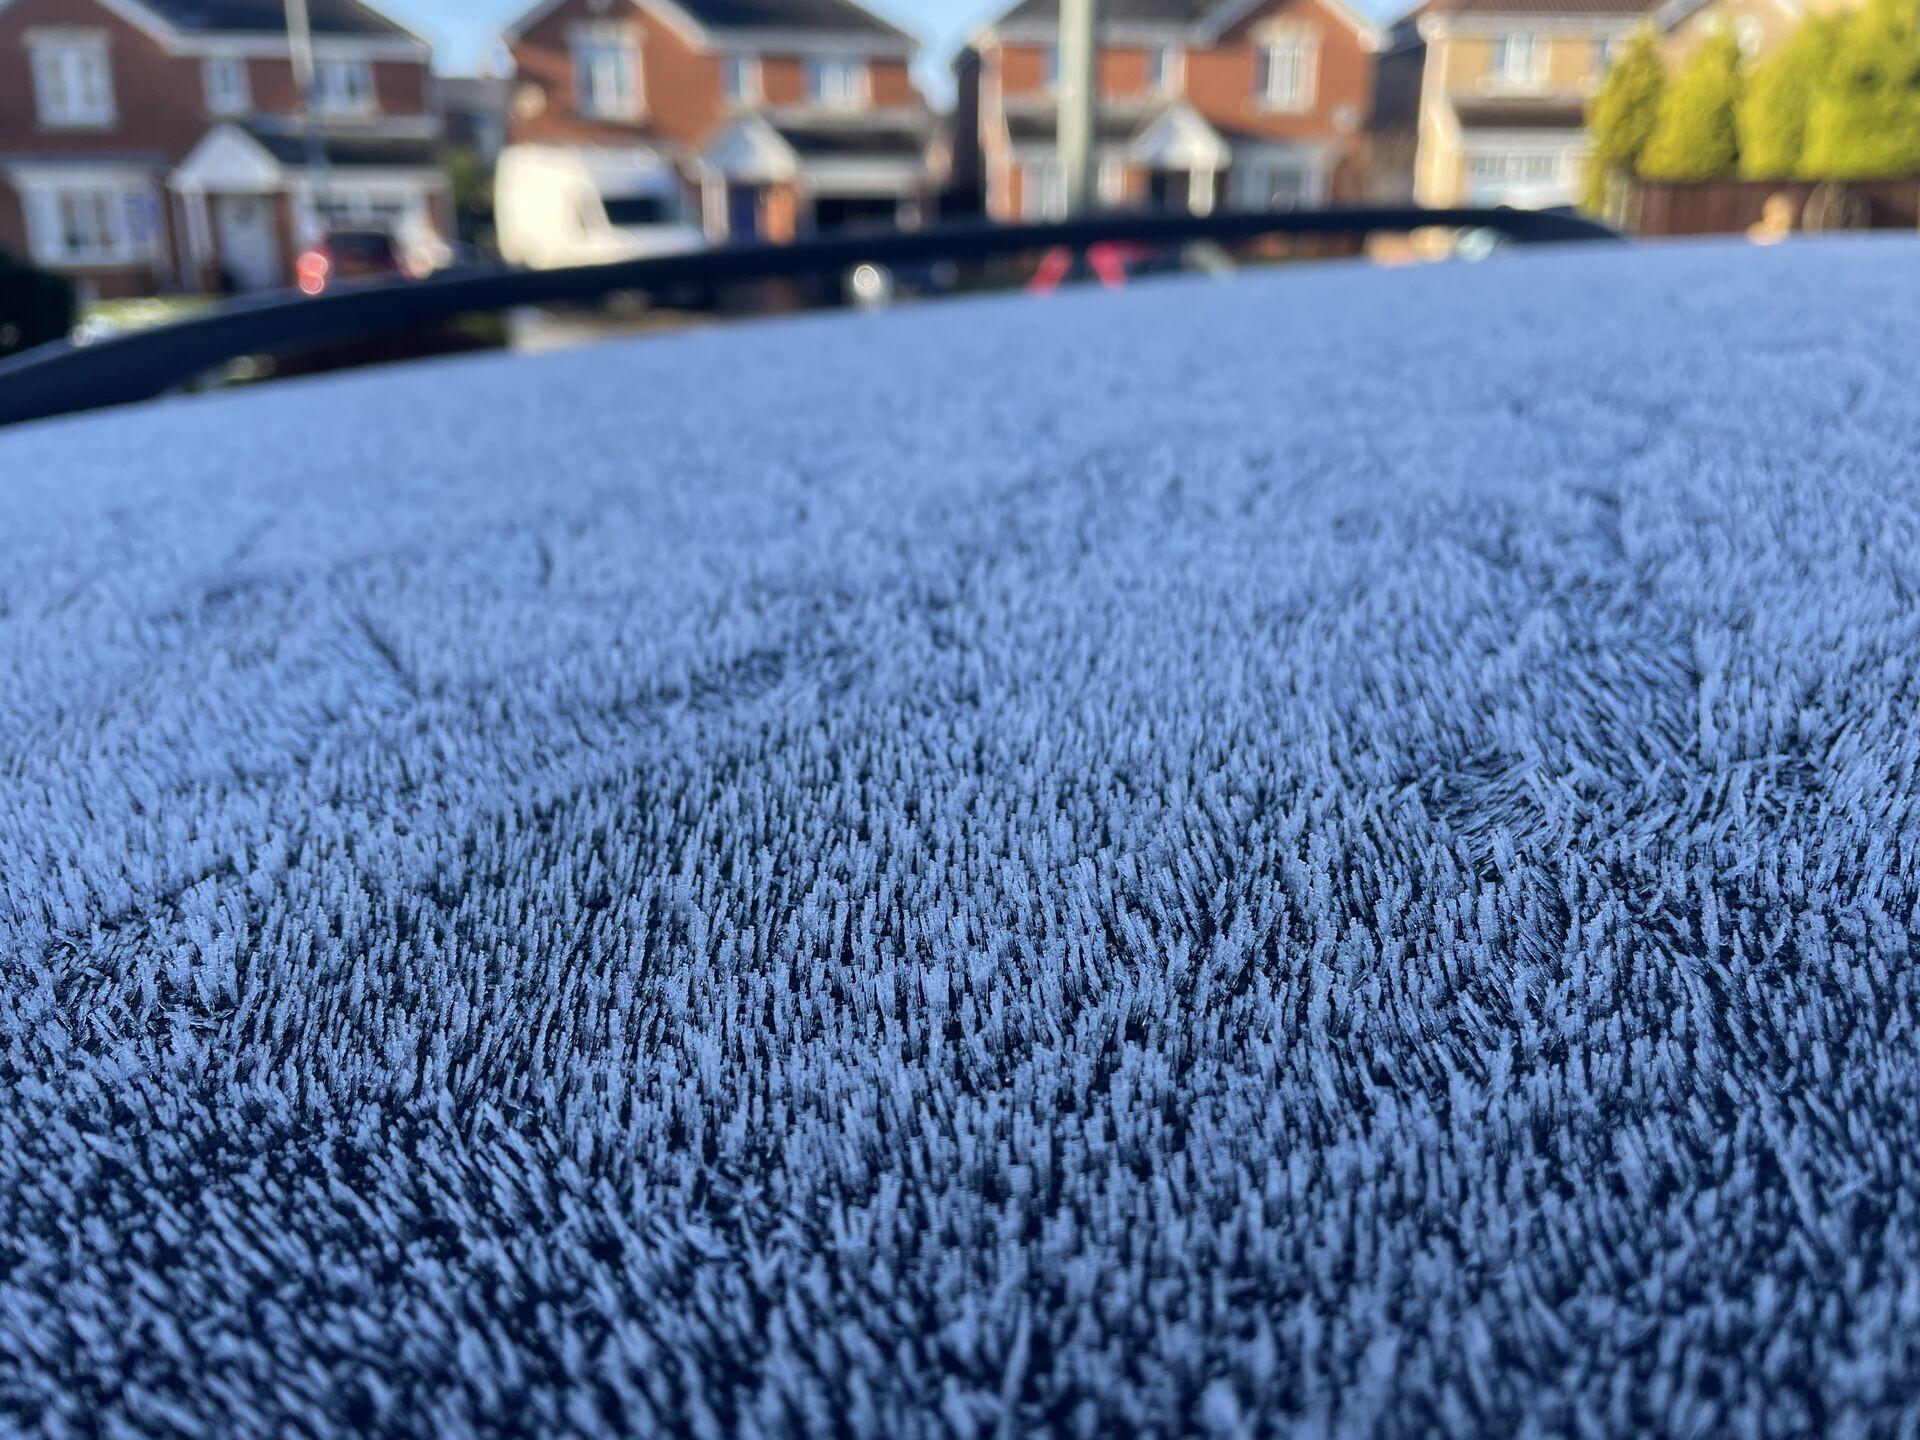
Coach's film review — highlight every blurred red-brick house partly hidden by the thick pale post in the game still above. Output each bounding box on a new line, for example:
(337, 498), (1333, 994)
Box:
(952, 0), (1382, 221)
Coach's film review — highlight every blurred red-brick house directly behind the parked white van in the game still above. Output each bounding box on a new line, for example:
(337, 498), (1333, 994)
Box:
(507, 0), (933, 240)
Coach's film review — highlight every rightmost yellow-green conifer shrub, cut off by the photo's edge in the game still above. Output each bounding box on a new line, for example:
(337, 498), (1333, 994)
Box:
(1799, 0), (1920, 180)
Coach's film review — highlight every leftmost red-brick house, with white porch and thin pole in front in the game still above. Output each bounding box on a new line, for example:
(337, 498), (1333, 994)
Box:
(0, 0), (449, 298)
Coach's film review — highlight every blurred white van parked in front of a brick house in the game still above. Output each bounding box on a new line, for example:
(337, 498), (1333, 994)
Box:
(493, 146), (705, 271)
